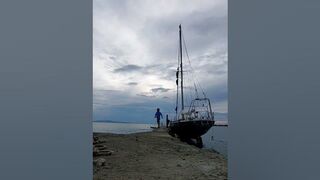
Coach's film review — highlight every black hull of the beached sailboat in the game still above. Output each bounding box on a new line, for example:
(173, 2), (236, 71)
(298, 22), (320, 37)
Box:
(169, 120), (214, 139)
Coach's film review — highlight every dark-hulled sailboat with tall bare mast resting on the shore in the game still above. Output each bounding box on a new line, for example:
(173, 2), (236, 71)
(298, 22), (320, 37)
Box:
(168, 24), (215, 147)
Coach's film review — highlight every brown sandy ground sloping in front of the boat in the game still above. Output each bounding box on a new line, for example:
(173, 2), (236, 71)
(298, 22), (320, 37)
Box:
(93, 129), (227, 180)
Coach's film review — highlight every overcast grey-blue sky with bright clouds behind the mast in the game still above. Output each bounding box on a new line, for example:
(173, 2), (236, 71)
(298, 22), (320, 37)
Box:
(93, 0), (228, 122)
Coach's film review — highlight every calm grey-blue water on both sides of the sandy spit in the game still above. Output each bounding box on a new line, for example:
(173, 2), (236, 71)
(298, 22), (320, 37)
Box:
(93, 122), (228, 157)
